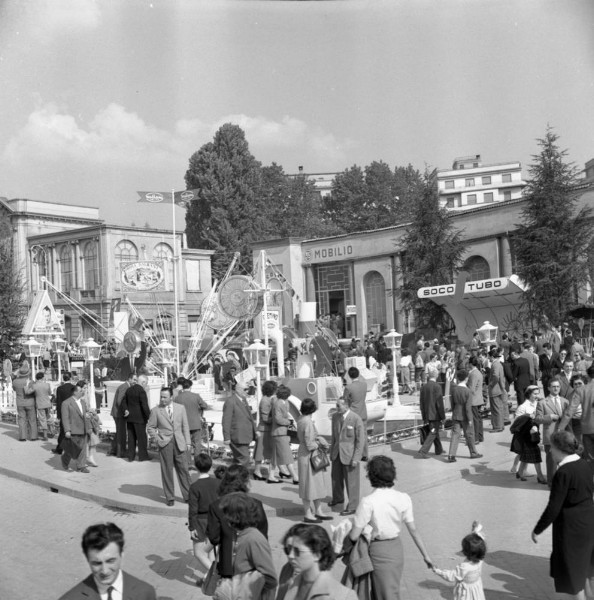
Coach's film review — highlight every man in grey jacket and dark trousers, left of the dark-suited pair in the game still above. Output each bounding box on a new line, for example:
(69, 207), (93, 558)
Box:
(60, 379), (90, 473)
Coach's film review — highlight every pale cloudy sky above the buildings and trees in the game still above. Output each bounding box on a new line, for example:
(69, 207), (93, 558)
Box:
(0, 0), (594, 228)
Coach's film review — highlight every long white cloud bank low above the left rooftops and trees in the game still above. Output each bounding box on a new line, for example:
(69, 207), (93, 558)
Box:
(2, 104), (353, 171)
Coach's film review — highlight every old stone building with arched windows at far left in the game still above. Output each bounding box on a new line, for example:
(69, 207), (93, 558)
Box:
(0, 198), (212, 339)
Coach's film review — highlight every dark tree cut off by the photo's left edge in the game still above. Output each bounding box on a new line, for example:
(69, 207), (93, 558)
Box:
(0, 217), (26, 354)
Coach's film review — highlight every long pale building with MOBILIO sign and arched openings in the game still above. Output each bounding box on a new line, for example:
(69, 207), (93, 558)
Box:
(254, 183), (594, 337)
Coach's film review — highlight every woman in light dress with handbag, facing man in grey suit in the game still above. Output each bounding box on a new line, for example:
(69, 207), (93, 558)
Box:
(297, 398), (332, 523)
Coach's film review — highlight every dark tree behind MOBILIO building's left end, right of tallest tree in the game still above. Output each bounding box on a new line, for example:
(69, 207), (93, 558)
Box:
(260, 163), (341, 239)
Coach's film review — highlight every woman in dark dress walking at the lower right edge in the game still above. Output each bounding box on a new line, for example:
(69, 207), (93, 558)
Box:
(532, 431), (594, 600)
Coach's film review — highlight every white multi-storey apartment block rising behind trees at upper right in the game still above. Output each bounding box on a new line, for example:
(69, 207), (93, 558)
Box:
(437, 154), (526, 210)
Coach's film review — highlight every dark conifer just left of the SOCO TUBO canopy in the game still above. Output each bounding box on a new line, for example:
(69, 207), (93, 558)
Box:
(397, 171), (465, 331)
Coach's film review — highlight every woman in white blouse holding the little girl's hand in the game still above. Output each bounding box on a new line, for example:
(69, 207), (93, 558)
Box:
(349, 455), (431, 600)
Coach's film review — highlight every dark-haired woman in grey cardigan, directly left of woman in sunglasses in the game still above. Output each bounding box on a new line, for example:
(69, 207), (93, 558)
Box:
(213, 492), (277, 600)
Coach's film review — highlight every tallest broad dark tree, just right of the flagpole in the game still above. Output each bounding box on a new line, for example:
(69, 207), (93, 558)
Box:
(185, 123), (264, 277)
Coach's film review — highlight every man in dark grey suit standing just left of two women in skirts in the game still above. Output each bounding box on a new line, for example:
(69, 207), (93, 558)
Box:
(222, 386), (256, 467)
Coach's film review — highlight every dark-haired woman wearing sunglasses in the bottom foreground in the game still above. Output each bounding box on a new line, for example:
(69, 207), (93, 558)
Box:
(276, 525), (357, 600)
